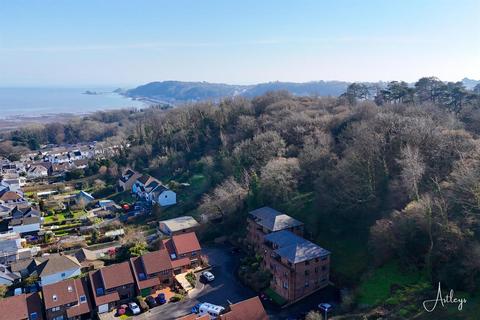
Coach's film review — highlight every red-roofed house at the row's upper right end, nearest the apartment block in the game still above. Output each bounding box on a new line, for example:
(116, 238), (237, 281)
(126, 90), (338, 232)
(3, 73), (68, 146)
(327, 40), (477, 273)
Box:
(162, 232), (202, 274)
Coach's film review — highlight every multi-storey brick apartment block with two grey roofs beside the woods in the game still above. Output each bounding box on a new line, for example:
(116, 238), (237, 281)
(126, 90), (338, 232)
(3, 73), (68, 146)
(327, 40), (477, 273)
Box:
(247, 207), (330, 303)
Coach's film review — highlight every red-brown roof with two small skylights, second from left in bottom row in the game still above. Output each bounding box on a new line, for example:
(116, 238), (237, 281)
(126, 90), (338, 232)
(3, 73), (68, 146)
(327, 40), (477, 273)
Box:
(42, 278), (91, 317)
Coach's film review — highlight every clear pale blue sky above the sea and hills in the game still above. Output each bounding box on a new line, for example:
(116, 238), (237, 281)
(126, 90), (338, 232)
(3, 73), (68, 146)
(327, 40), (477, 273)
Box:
(0, 0), (480, 86)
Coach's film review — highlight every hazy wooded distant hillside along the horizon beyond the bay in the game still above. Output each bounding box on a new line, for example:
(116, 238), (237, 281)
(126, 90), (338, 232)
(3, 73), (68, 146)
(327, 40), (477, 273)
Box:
(124, 81), (349, 104)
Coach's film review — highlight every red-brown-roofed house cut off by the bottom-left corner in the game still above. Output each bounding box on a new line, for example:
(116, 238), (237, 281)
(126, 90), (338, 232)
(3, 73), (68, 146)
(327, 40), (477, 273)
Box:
(0, 292), (45, 320)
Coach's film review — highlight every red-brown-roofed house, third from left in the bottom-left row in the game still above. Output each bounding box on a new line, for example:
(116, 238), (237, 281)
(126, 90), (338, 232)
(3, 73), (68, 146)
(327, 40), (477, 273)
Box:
(89, 261), (136, 313)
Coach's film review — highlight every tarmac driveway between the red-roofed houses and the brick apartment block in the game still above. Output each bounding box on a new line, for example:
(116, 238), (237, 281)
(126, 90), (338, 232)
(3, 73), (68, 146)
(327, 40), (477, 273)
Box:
(140, 247), (255, 320)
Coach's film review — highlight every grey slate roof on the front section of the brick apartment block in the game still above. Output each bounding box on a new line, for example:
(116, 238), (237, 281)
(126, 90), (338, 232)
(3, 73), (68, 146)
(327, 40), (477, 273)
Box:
(264, 230), (330, 264)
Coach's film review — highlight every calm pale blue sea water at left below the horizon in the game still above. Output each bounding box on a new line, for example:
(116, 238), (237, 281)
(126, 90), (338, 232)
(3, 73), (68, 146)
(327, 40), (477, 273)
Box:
(0, 88), (146, 119)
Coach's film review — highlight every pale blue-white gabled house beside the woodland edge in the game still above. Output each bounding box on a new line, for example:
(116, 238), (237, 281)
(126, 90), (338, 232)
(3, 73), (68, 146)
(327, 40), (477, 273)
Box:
(132, 175), (177, 206)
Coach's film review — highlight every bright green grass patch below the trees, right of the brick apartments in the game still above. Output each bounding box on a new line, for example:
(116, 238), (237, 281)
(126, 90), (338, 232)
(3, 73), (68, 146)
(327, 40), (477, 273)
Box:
(358, 261), (425, 306)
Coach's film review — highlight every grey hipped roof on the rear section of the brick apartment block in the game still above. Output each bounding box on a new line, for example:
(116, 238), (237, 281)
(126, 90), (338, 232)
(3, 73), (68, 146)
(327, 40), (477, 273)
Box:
(250, 207), (303, 232)
